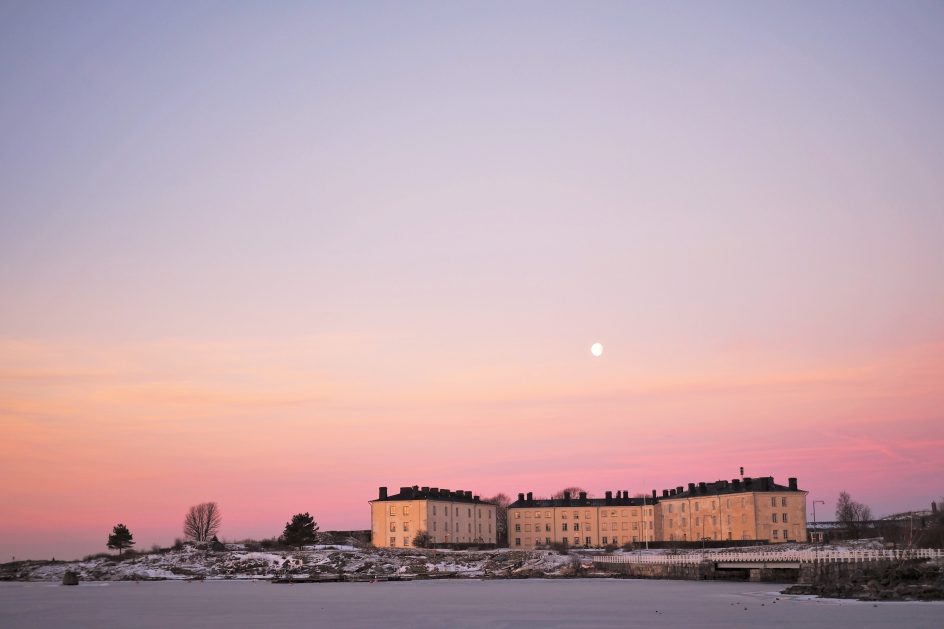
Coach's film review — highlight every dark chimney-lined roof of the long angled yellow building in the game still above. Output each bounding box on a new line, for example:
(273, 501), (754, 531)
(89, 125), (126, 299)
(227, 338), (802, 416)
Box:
(508, 476), (802, 508)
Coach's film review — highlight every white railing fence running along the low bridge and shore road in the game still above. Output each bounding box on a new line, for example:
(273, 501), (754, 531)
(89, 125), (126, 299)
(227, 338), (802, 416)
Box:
(593, 548), (944, 564)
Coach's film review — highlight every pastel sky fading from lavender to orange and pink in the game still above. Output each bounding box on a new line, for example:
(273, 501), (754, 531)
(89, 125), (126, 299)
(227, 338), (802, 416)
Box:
(0, 0), (944, 561)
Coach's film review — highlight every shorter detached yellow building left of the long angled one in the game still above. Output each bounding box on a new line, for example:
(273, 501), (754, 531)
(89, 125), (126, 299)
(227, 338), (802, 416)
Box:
(370, 485), (497, 548)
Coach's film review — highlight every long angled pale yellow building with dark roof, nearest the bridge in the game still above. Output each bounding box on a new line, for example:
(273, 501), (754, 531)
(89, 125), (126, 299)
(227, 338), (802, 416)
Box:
(508, 476), (807, 548)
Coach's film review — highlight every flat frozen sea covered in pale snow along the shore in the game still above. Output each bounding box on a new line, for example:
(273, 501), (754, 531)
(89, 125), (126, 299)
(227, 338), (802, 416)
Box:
(0, 579), (944, 629)
